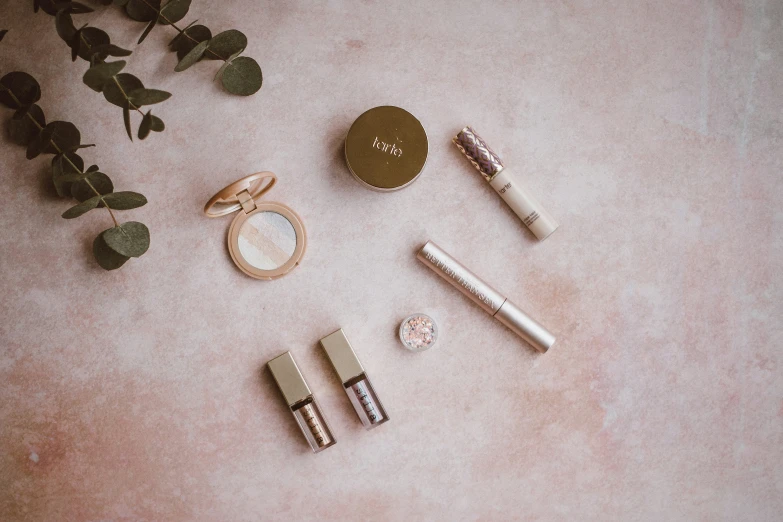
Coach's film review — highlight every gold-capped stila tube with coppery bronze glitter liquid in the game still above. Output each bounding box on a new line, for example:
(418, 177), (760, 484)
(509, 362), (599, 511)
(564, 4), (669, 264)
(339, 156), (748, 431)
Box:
(266, 352), (337, 453)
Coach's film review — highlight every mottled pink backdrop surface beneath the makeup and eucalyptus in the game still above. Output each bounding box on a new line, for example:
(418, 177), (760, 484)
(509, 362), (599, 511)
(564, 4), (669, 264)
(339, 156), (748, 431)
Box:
(0, 0), (783, 521)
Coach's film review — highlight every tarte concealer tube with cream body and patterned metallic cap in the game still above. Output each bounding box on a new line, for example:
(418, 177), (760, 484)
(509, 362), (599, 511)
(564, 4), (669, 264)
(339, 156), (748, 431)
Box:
(452, 127), (559, 241)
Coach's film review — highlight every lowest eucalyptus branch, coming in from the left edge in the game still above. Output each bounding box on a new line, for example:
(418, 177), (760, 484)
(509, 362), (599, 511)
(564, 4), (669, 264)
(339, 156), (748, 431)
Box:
(0, 72), (150, 270)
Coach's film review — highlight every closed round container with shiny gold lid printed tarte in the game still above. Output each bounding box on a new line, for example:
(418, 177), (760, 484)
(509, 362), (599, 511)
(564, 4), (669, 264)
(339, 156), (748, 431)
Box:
(345, 105), (429, 191)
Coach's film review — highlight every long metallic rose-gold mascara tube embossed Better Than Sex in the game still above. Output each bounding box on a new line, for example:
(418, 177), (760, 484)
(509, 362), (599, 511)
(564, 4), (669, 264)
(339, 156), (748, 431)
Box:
(416, 241), (555, 353)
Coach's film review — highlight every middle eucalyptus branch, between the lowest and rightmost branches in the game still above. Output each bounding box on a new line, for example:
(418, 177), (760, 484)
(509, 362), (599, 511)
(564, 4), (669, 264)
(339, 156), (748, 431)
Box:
(33, 0), (171, 140)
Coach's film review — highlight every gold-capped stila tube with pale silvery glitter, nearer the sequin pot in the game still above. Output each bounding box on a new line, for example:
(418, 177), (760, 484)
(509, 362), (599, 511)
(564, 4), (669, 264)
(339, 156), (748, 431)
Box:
(321, 328), (389, 430)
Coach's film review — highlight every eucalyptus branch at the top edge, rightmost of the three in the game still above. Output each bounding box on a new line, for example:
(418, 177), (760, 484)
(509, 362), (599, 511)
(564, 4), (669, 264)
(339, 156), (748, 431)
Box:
(110, 0), (263, 96)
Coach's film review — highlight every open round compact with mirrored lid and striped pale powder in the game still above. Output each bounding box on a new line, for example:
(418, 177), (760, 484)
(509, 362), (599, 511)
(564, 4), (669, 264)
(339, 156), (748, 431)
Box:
(204, 172), (307, 280)
